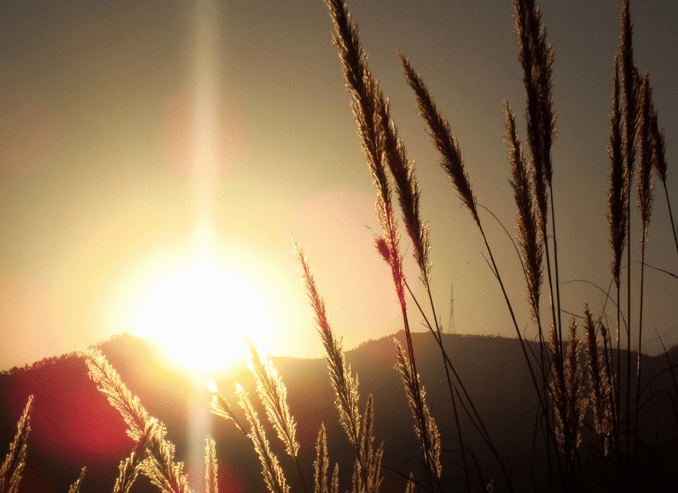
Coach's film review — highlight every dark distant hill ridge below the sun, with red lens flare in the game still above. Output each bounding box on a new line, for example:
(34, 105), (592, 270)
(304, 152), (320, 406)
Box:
(0, 333), (678, 493)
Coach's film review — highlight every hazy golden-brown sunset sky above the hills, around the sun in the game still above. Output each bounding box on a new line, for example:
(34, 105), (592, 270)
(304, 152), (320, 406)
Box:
(0, 0), (678, 370)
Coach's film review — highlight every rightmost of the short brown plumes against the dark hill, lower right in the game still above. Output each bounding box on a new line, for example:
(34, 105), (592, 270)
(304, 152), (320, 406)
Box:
(584, 303), (614, 457)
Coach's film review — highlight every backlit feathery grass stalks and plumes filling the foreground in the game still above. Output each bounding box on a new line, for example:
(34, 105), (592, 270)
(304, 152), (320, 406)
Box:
(0, 0), (678, 493)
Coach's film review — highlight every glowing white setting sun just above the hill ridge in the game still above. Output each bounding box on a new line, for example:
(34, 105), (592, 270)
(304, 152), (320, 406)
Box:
(132, 257), (273, 378)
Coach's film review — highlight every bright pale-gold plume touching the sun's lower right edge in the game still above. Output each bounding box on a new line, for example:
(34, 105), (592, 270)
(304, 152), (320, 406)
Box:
(249, 344), (299, 457)
